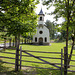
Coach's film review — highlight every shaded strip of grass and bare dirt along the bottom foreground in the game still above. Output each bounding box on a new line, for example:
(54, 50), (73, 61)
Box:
(0, 59), (75, 75)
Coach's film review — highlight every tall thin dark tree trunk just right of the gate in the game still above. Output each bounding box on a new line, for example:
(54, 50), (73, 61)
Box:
(64, 0), (70, 75)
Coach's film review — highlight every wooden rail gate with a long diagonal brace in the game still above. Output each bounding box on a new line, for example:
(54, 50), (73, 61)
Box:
(18, 47), (63, 75)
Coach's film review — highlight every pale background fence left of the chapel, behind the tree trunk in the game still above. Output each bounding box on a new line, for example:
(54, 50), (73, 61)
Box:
(0, 38), (32, 48)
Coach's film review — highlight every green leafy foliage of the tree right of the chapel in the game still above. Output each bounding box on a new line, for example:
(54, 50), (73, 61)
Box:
(43, 0), (75, 49)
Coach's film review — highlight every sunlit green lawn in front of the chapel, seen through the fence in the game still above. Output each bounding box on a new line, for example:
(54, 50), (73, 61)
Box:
(0, 43), (75, 75)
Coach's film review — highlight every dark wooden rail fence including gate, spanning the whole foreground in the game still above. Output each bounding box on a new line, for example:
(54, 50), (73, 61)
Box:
(0, 40), (75, 75)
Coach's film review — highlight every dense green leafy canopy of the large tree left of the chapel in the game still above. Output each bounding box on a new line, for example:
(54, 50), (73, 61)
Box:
(0, 0), (38, 46)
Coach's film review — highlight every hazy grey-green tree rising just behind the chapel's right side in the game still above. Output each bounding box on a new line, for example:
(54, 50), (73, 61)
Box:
(45, 20), (56, 39)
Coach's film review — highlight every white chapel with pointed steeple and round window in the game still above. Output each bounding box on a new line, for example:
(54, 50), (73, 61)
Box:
(32, 9), (50, 45)
